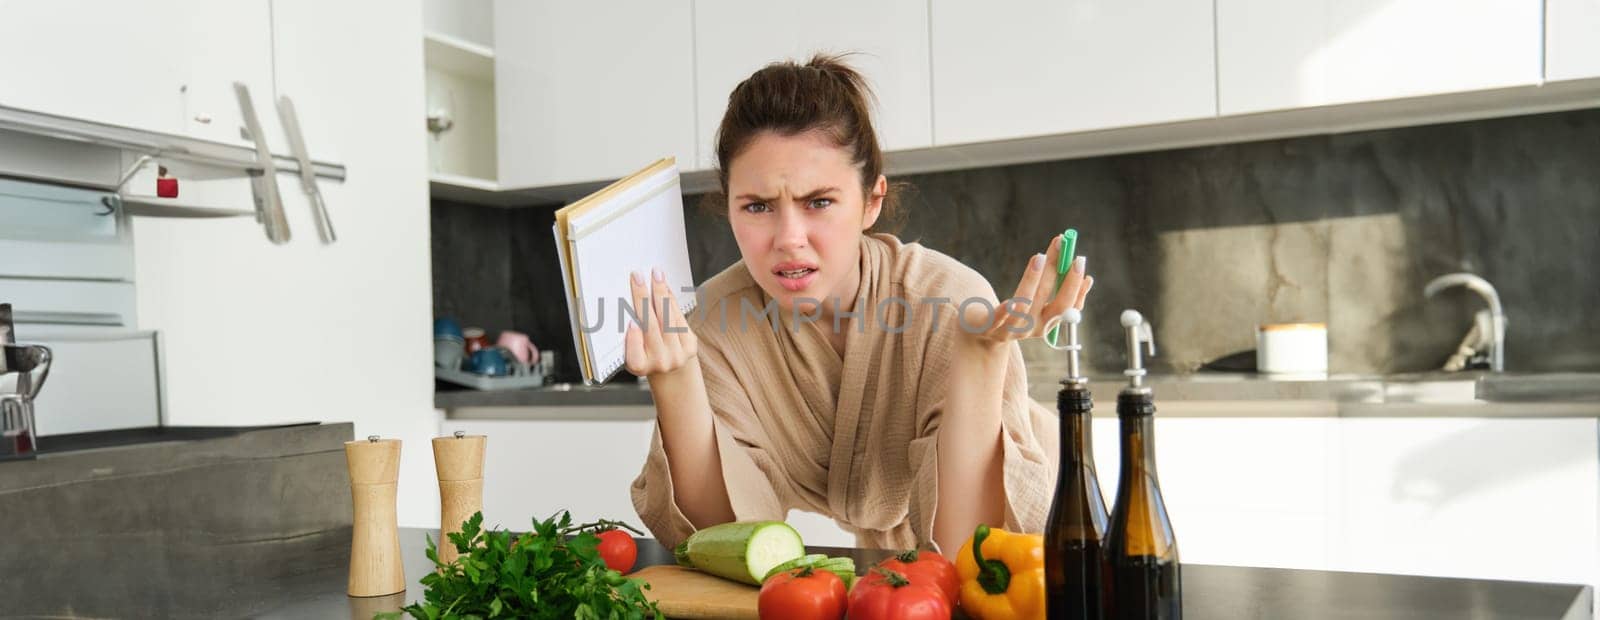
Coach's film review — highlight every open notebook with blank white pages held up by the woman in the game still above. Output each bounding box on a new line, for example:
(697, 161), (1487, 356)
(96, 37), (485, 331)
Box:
(554, 157), (694, 385)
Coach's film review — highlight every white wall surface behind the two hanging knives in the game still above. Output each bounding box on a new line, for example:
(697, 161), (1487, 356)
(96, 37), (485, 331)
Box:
(134, 0), (438, 526)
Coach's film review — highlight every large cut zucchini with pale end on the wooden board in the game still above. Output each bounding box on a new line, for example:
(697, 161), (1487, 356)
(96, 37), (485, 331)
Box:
(674, 521), (805, 585)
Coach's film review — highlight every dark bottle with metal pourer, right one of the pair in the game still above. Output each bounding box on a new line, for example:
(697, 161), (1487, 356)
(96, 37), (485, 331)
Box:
(1106, 310), (1182, 618)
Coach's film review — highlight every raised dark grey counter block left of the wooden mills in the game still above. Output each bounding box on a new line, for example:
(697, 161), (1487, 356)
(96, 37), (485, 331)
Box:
(0, 423), (354, 618)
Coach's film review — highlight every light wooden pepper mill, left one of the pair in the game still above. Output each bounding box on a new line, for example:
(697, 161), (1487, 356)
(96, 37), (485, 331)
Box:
(344, 435), (405, 596)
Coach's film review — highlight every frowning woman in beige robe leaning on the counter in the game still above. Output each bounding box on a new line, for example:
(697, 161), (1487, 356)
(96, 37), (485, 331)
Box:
(627, 56), (1093, 554)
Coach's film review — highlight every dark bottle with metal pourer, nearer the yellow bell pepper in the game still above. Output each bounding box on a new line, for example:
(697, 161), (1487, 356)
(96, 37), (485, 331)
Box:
(1045, 308), (1109, 620)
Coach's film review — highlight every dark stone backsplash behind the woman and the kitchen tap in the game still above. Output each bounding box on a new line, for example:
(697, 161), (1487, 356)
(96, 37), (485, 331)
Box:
(432, 109), (1600, 380)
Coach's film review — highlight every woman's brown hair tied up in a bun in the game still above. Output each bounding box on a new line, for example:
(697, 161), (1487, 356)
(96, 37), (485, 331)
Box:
(704, 53), (904, 229)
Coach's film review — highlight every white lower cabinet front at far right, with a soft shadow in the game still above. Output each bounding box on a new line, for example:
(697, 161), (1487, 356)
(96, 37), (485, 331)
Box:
(1330, 419), (1600, 583)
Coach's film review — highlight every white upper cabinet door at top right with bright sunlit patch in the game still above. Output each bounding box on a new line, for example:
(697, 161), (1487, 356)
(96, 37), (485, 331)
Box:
(1216, 0), (1544, 115)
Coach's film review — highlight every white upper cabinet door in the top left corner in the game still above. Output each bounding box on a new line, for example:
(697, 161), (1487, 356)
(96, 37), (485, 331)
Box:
(0, 0), (187, 133)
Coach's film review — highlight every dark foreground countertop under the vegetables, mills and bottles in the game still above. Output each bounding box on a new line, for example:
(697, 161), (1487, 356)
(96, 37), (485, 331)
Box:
(40, 529), (1574, 620)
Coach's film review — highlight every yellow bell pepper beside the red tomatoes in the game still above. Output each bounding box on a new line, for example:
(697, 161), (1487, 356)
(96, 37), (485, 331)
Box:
(955, 524), (1045, 620)
